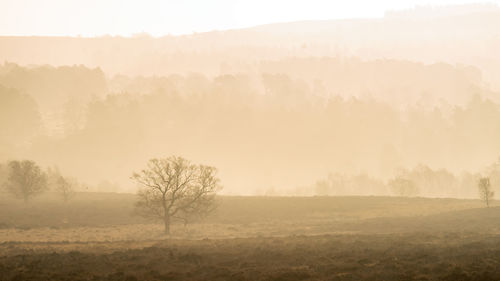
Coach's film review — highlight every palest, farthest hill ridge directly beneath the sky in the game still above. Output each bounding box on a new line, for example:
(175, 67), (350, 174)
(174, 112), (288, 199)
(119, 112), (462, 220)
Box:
(0, 5), (500, 89)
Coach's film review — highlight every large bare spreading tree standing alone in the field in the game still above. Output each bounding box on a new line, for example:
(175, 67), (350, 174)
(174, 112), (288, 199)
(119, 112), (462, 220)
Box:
(132, 156), (222, 234)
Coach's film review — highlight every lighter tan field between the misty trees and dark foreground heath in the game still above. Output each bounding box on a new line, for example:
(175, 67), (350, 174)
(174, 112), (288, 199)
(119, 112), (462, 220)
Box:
(0, 193), (500, 242)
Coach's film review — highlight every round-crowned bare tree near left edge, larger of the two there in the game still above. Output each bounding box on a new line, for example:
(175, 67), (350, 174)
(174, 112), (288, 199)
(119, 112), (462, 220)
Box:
(6, 160), (47, 203)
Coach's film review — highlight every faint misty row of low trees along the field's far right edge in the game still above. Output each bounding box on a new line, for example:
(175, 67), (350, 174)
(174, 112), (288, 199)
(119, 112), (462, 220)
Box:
(310, 160), (500, 198)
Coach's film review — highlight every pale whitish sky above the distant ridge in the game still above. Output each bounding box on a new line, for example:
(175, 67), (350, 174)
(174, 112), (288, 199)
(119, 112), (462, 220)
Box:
(0, 0), (500, 36)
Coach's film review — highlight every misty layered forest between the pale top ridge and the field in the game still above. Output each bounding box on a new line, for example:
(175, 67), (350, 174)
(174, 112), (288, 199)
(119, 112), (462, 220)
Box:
(0, 58), (500, 197)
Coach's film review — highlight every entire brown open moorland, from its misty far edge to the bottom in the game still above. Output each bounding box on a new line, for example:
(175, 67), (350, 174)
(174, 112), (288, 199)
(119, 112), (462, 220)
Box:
(0, 193), (500, 280)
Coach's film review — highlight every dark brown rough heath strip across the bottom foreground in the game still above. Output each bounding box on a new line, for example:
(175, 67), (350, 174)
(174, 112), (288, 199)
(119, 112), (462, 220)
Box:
(0, 233), (500, 280)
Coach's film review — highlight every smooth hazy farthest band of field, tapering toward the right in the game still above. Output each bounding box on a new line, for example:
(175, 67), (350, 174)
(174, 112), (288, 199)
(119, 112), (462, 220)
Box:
(0, 192), (483, 229)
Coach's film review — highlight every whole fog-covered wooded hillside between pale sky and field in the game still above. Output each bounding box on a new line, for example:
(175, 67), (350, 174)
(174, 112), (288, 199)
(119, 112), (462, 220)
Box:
(0, 5), (500, 198)
